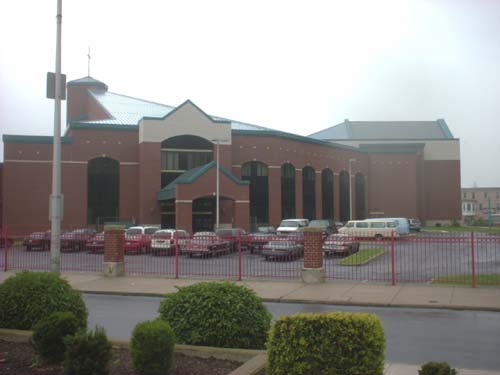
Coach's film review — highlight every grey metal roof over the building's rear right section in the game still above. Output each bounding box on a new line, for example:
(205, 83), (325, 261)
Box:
(309, 119), (453, 140)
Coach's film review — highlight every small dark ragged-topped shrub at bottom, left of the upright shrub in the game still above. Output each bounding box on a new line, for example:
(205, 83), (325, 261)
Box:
(64, 327), (111, 375)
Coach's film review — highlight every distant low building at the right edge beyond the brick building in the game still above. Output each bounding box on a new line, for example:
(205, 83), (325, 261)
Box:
(462, 187), (500, 224)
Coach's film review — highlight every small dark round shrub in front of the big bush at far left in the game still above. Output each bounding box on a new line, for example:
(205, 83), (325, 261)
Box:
(33, 311), (82, 362)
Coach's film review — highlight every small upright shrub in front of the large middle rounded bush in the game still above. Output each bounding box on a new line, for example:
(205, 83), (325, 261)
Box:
(130, 319), (175, 375)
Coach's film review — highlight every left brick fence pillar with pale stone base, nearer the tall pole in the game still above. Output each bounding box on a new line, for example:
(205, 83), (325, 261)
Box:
(102, 225), (125, 276)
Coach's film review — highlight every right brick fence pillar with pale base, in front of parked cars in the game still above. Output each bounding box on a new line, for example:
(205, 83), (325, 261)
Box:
(302, 227), (325, 283)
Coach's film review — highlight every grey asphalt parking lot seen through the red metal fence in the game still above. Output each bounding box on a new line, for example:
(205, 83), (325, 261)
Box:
(0, 233), (500, 284)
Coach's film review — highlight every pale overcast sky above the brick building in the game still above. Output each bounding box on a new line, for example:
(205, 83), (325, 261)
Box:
(0, 0), (500, 187)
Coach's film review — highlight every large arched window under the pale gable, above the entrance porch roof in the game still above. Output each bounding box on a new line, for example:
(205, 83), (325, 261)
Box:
(161, 135), (213, 188)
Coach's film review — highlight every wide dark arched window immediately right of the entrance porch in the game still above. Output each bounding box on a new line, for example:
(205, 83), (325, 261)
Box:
(241, 161), (269, 224)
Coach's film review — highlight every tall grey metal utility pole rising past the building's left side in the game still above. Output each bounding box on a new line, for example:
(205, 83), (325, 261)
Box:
(50, 0), (62, 273)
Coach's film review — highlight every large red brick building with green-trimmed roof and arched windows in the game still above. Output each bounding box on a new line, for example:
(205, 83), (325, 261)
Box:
(0, 77), (461, 232)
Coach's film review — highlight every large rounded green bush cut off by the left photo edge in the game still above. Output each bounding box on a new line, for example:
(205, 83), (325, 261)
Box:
(0, 272), (87, 330)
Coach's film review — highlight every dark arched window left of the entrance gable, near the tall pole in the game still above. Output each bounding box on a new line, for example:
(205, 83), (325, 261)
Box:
(87, 158), (120, 224)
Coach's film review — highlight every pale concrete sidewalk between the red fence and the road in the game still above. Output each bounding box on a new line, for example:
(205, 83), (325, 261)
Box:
(0, 271), (500, 311)
